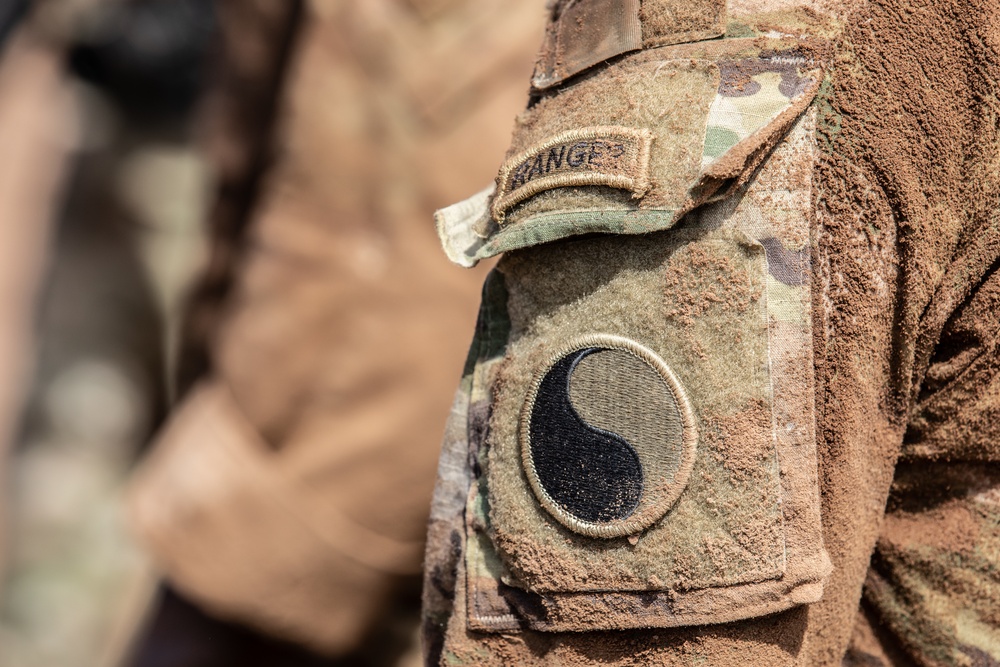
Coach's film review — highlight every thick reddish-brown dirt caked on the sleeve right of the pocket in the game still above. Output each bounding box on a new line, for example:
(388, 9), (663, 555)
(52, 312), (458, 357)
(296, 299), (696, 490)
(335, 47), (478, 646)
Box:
(806, 0), (1000, 665)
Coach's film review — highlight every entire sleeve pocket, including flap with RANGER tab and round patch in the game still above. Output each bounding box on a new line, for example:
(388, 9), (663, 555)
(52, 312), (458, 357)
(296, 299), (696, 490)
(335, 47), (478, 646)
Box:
(438, 43), (830, 632)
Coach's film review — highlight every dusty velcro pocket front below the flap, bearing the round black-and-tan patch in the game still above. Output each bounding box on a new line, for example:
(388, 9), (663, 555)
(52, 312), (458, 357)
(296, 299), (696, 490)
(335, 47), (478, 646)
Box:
(463, 112), (830, 632)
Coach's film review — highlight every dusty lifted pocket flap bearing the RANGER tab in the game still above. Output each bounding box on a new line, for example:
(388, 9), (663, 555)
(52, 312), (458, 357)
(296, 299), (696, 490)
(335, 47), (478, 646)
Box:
(435, 39), (820, 266)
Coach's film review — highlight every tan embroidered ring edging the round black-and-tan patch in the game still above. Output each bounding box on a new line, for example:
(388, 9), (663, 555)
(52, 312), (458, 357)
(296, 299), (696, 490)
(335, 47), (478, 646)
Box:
(518, 334), (698, 538)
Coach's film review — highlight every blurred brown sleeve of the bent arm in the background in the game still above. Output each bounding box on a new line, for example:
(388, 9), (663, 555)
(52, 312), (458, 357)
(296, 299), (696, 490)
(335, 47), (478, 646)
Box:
(132, 0), (544, 655)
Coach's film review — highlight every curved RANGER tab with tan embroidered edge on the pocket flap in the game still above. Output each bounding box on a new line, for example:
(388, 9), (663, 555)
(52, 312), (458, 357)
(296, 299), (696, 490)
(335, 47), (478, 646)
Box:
(491, 126), (653, 223)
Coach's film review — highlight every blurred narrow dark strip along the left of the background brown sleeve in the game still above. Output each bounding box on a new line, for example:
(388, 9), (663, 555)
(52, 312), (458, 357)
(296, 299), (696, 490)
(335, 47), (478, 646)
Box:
(175, 0), (305, 395)
